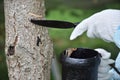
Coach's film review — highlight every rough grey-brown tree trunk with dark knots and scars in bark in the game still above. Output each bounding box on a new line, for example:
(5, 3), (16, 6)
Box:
(4, 0), (53, 80)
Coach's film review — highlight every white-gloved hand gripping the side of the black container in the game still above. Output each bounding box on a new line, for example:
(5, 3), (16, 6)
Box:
(95, 48), (114, 80)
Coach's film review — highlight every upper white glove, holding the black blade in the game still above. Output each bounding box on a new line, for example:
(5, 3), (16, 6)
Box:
(70, 9), (120, 42)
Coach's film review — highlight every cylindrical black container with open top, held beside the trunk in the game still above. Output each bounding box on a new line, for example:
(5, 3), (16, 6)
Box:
(61, 48), (100, 80)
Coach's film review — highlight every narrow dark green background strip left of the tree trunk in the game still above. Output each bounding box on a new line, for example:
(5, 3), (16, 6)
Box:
(0, 0), (8, 80)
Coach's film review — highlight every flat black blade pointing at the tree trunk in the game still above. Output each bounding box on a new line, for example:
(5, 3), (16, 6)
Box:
(31, 19), (79, 28)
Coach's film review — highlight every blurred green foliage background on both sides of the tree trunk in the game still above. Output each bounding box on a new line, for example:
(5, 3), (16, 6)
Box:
(0, 0), (120, 80)
